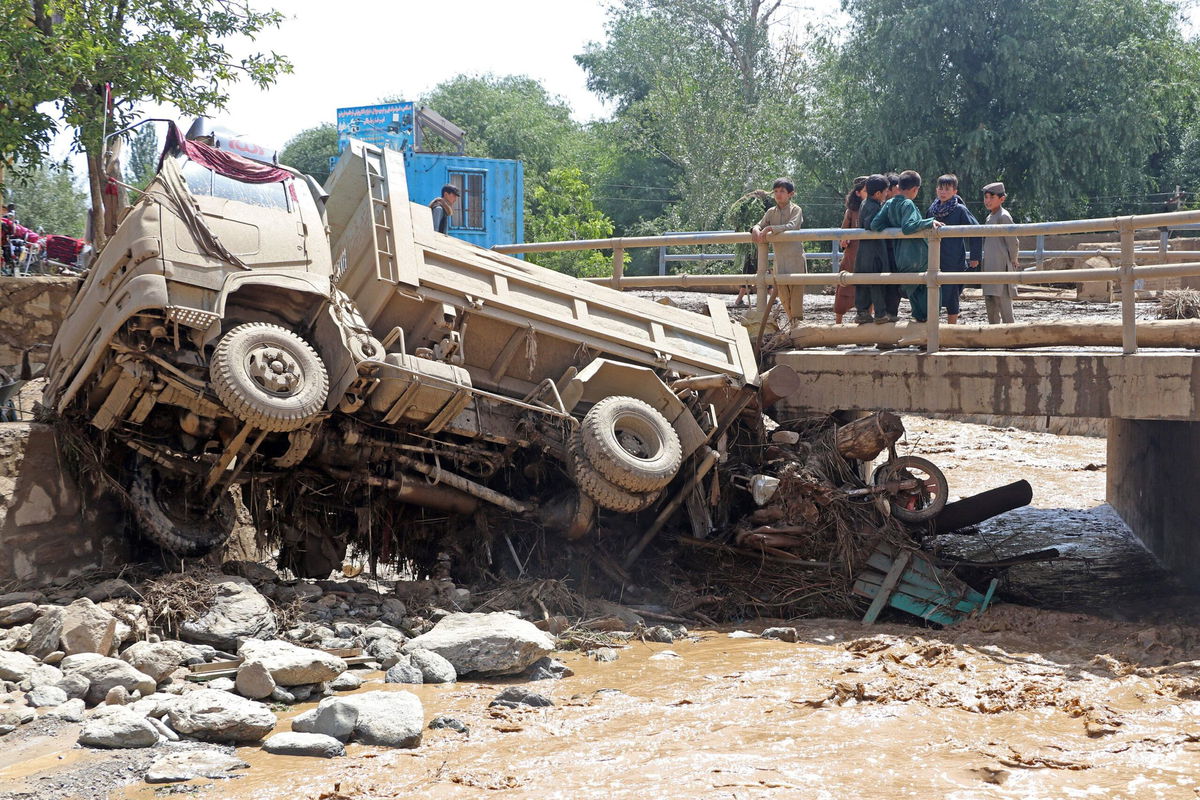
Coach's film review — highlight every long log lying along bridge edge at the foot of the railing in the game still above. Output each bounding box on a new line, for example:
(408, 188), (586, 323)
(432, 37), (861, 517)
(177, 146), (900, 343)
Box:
(781, 319), (1200, 349)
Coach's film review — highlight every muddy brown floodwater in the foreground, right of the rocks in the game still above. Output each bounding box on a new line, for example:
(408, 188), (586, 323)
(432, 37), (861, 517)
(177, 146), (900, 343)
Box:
(93, 606), (1200, 800)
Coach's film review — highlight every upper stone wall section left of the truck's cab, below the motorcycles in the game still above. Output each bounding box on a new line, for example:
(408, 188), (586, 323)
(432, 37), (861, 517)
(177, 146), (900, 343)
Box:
(0, 277), (80, 371)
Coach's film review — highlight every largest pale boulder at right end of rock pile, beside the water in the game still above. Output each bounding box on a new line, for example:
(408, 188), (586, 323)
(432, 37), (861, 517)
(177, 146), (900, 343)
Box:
(402, 613), (554, 676)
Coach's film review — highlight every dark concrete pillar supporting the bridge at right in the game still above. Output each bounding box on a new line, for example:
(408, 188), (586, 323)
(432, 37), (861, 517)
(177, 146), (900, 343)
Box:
(1106, 417), (1200, 587)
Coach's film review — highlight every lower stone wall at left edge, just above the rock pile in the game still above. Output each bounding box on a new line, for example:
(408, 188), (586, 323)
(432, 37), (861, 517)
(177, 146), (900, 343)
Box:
(0, 422), (128, 585)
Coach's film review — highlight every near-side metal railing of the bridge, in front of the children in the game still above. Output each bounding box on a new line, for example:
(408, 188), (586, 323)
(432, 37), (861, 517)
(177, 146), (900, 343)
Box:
(492, 211), (1200, 354)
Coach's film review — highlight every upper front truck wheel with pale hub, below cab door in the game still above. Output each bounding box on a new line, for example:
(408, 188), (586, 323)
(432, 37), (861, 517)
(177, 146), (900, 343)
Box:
(209, 323), (329, 431)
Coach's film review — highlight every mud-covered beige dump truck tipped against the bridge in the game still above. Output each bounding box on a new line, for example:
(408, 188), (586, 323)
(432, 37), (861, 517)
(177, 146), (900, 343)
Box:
(44, 126), (760, 577)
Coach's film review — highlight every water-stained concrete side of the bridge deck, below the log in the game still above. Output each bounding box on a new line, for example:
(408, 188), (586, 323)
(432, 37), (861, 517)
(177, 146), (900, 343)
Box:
(774, 348), (1200, 421)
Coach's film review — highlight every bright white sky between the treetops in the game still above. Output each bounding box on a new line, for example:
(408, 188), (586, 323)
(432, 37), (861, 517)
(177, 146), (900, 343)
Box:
(141, 0), (608, 153)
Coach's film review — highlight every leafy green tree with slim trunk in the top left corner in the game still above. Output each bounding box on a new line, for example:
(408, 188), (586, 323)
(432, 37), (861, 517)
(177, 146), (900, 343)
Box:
(18, 0), (290, 243)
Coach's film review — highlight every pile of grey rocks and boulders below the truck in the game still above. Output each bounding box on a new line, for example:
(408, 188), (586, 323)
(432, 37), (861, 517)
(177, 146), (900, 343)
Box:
(0, 561), (624, 782)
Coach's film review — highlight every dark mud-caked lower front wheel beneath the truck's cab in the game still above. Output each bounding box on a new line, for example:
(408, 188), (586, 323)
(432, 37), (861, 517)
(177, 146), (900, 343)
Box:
(130, 467), (238, 555)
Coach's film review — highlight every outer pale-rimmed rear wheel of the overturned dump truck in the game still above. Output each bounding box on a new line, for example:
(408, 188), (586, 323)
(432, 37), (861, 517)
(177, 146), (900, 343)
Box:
(580, 396), (683, 493)
